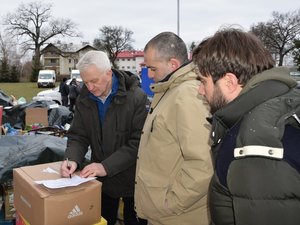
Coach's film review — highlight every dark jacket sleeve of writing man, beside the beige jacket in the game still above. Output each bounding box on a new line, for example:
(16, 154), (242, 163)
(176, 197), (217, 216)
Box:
(102, 88), (148, 177)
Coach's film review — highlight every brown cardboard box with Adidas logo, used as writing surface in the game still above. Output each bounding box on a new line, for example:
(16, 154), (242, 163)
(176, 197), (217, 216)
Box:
(13, 162), (101, 225)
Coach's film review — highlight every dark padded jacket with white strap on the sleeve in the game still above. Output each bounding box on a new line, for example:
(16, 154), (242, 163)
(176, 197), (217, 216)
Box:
(209, 68), (300, 225)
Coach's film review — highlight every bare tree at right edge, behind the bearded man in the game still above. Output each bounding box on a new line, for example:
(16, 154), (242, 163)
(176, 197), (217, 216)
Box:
(250, 9), (300, 66)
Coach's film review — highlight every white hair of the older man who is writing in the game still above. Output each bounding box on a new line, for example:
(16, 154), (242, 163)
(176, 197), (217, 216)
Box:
(76, 51), (111, 72)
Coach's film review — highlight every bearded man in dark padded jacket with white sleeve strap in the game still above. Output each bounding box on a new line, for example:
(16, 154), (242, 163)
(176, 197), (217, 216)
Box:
(193, 27), (300, 225)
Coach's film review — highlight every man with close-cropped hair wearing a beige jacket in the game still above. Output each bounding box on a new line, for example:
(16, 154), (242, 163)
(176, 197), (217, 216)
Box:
(135, 32), (213, 225)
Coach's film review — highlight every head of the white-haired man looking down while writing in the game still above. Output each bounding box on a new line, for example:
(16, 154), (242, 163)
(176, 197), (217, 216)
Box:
(76, 51), (112, 97)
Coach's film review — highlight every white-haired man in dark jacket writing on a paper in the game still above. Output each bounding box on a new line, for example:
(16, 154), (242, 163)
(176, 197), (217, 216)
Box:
(61, 51), (148, 225)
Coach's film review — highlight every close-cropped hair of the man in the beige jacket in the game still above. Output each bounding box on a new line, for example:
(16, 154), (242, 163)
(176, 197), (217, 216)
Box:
(144, 32), (188, 64)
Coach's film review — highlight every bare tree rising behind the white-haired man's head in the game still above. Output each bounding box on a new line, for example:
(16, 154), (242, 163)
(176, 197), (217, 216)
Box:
(94, 26), (134, 67)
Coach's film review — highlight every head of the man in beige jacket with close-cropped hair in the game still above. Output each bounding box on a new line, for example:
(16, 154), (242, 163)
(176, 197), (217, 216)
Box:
(144, 32), (188, 83)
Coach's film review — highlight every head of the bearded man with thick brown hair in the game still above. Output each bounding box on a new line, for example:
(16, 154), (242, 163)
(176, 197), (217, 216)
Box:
(193, 28), (275, 113)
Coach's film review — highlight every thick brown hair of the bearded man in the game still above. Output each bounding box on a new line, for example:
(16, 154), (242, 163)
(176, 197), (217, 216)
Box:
(193, 28), (275, 85)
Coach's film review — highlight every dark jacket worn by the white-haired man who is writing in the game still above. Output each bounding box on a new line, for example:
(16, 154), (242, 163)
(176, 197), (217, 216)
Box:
(65, 70), (148, 197)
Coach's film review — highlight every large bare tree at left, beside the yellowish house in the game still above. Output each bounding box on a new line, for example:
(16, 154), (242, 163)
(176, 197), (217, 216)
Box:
(4, 1), (79, 81)
